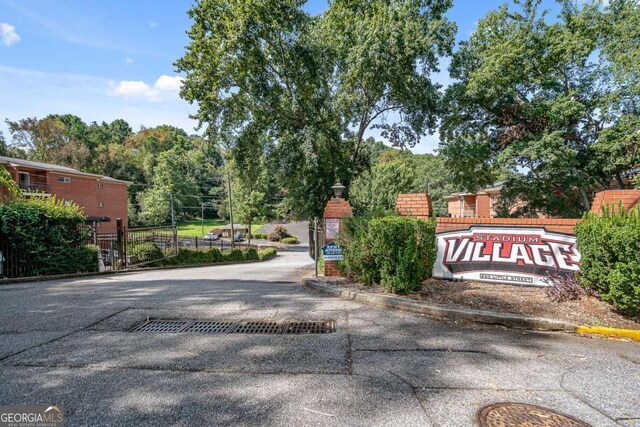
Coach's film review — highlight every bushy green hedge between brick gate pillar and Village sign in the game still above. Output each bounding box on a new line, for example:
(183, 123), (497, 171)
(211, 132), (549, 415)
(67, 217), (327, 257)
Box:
(340, 216), (437, 294)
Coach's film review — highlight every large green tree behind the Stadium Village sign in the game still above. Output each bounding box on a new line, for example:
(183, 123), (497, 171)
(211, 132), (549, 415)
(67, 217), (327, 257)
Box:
(441, 0), (640, 217)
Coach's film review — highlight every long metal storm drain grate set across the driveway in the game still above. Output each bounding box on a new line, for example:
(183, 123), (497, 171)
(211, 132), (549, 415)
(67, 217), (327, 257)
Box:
(131, 320), (336, 334)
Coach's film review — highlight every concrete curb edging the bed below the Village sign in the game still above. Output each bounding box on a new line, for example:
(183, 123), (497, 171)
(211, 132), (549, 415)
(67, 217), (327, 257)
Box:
(302, 279), (576, 332)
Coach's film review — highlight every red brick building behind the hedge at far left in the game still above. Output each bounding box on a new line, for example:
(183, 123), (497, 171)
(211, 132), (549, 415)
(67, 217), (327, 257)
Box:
(0, 156), (131, 233)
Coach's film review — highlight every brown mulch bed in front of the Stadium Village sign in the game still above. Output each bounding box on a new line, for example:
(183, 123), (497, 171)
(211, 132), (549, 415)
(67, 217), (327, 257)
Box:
(343, 279), (640, 329)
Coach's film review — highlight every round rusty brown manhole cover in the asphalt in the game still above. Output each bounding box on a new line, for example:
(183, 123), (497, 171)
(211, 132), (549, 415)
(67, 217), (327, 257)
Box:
(478, 402), (589, 427)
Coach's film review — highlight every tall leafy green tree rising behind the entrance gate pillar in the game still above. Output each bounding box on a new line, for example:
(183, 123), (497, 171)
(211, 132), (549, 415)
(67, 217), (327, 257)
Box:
(176, 0), (455, 216)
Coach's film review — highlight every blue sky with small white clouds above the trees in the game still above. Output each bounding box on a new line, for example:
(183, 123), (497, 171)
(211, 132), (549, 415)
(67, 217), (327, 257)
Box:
(0, 0), (554, 153)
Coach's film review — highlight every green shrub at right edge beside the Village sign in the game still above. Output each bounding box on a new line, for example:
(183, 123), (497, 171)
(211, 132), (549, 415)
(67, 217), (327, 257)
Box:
(575, 207), (640, 316)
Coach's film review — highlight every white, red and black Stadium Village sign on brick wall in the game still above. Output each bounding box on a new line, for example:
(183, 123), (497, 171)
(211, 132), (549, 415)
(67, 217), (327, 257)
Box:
(433, 226), (580, 286)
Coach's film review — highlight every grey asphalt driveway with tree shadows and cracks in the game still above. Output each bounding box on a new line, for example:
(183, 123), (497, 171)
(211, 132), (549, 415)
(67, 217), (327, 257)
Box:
(0, 252), (640, 427)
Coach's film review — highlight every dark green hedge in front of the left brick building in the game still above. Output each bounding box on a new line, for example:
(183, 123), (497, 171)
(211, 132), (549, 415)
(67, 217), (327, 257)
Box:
(0, 197), (98, 276)
